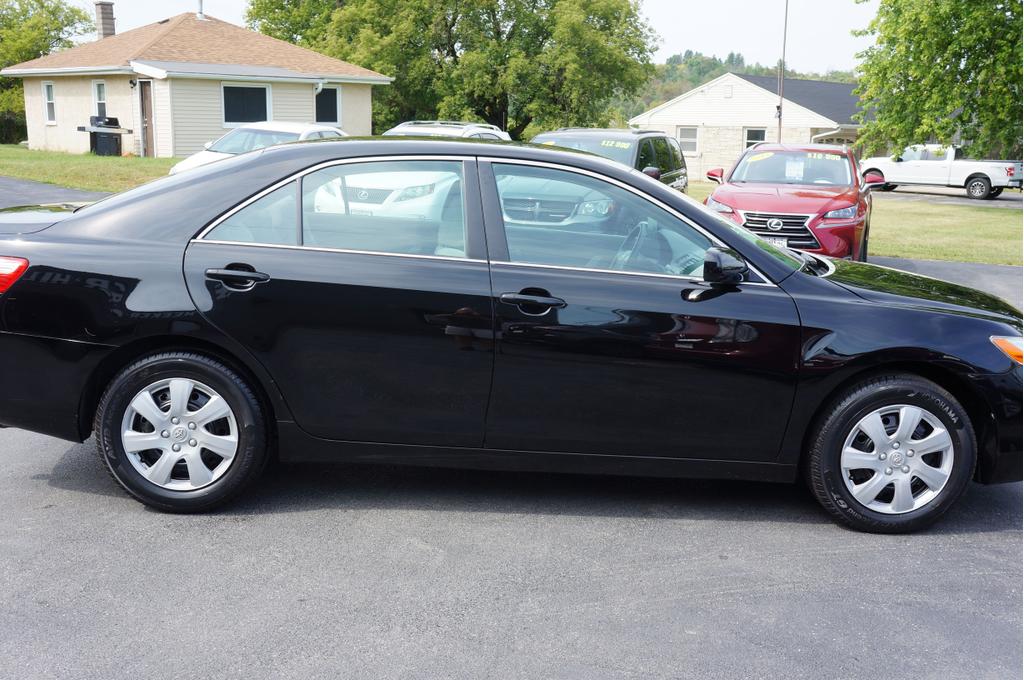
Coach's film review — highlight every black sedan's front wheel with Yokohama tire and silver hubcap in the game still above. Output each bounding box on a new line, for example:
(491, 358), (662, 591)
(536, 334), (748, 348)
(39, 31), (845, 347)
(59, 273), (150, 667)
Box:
(807, 375), (977, 534)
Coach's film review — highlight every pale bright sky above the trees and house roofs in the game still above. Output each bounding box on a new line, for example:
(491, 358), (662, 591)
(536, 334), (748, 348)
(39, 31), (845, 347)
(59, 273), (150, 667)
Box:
(73, 0), (879, 73)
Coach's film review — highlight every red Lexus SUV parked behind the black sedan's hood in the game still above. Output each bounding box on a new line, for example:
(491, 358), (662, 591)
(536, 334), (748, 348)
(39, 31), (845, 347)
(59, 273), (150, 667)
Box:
(705, 143), (884, 261)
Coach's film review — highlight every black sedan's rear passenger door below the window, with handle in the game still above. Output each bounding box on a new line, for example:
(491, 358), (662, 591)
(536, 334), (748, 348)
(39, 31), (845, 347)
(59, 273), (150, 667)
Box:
(184, 156), (494, 447)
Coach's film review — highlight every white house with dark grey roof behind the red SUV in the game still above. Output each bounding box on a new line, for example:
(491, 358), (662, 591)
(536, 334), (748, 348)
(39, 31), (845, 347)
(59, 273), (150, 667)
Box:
(630, 73), (860, 176)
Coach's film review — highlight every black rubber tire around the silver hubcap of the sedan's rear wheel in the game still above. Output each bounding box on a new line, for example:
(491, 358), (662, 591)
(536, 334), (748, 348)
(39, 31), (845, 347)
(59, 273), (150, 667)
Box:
(94, 352), (268, 513)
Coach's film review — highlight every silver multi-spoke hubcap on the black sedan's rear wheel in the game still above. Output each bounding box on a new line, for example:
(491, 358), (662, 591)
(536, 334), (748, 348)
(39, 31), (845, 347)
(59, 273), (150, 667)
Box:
(121, 378), (239, 492)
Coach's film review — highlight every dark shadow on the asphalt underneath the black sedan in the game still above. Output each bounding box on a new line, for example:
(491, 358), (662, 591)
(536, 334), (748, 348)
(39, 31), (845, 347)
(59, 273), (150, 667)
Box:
(47, 441), (1022, 534)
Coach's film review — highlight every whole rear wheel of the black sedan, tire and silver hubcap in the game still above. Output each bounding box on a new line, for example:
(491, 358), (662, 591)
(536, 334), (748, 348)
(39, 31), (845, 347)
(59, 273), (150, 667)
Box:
(95, 352), (267, 512)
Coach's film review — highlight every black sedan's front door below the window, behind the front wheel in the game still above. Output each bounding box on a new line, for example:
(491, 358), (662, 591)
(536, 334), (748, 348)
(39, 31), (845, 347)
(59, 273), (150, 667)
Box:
(480, 163), (800, 462)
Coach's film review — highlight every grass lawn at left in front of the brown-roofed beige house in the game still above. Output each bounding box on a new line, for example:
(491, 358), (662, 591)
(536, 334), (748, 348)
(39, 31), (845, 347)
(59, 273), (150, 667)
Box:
(0, 144), (179, 192)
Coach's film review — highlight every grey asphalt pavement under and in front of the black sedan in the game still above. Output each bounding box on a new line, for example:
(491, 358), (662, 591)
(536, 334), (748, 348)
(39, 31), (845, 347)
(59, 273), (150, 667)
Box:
(0, 174), (1024, 680)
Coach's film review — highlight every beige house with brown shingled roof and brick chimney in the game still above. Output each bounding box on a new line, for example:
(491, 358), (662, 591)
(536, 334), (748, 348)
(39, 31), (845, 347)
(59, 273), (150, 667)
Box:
(0, 1), (391, 157)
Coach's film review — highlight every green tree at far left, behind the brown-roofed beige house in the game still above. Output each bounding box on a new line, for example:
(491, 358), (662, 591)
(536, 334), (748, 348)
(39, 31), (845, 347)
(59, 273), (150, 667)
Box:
(0, 0), (94, 142)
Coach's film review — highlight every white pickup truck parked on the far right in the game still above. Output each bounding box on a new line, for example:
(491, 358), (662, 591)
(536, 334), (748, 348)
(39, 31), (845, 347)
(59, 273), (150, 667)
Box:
(860, 144), (1021, 199)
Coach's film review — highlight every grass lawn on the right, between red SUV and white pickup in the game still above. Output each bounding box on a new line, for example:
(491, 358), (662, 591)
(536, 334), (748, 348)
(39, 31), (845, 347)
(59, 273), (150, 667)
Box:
(687, 182), (1024, 265)
